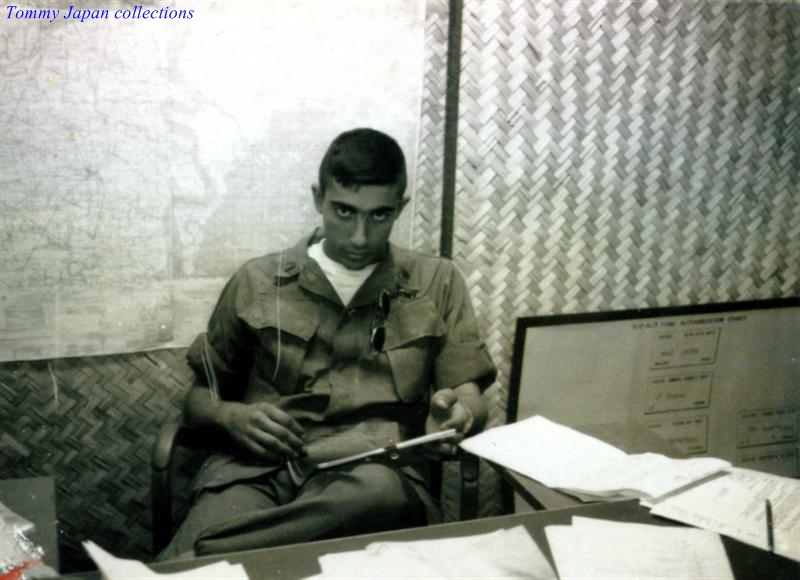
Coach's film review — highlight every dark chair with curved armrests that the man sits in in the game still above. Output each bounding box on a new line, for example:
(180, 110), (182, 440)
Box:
(150, 420), (479, 554)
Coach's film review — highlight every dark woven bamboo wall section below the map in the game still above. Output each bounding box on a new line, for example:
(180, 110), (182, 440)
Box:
(0, 350), (189, 573)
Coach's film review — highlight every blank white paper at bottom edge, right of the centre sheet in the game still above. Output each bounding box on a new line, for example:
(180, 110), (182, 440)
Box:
(545, 517), (733, 580)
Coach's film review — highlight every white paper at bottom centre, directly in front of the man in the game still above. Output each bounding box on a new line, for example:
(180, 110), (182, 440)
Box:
(314, 526), (556, 579)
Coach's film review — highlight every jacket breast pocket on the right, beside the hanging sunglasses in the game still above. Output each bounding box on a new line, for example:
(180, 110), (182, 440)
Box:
(384, 299), (445, 403)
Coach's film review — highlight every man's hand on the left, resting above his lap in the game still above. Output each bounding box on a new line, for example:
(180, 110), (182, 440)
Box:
(219, 402), (303, 459)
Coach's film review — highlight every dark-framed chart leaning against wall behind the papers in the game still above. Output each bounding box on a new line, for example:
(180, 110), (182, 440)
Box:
(508, 298), (800, 477)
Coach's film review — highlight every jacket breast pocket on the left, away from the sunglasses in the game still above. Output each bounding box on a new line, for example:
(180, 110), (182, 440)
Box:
(239, 300), (319, 395)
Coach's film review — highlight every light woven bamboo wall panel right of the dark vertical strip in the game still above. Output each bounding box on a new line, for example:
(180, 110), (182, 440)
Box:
(410, 0), (800, 412)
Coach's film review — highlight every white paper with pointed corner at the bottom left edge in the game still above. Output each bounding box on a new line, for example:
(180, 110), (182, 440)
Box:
(83, 541), (248, 580)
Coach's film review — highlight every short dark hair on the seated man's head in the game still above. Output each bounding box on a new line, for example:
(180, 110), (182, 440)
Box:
(319, 128), (407, 197)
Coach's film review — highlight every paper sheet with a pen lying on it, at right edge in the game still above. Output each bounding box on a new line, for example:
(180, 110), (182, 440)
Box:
(651, 468), (800, 562)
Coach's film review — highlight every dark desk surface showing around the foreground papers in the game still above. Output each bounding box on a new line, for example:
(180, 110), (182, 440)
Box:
(65, 501), (800, 580)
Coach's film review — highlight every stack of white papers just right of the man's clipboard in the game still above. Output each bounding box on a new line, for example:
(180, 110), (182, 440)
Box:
(461, 416), (730, 501)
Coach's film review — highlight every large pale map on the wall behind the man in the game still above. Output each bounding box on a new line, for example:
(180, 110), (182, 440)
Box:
(0, 0), (424, 360)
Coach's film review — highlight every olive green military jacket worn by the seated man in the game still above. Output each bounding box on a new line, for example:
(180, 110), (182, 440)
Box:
(187, 232), (496, 489)
